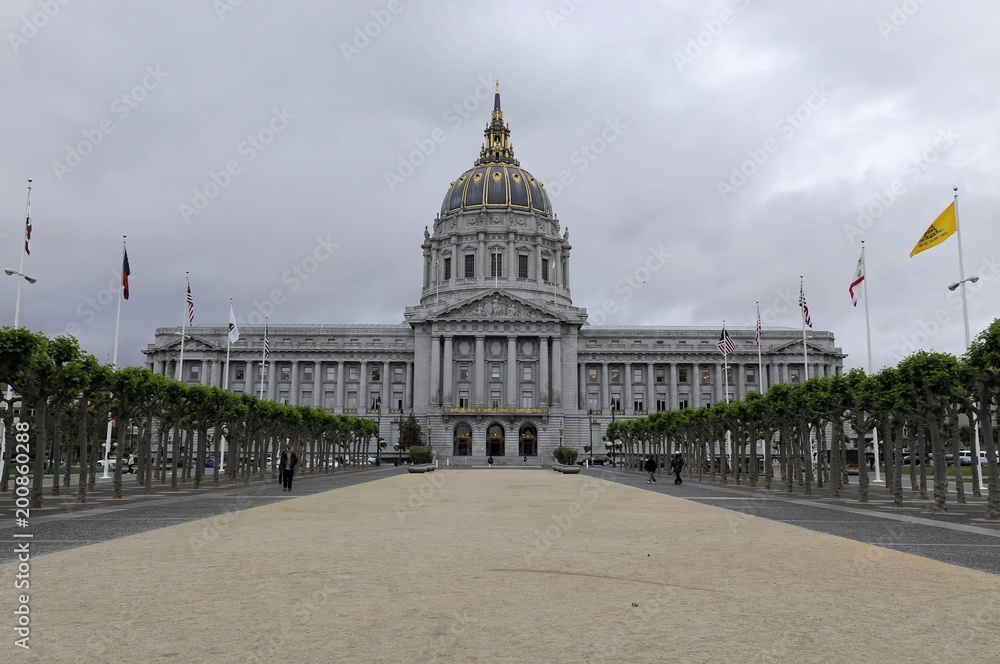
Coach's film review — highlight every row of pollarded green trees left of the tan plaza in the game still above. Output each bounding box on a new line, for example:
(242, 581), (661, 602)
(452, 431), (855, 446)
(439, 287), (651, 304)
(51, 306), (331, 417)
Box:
(0, 327), (378, 508)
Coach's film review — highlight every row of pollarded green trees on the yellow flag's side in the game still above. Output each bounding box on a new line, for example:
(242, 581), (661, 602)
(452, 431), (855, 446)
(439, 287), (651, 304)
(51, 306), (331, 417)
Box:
(607, 319), (1000, 519)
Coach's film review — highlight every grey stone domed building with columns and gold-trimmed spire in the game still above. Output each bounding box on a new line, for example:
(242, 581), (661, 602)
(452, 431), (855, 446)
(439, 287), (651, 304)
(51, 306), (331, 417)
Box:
(144, 89), (845, 464)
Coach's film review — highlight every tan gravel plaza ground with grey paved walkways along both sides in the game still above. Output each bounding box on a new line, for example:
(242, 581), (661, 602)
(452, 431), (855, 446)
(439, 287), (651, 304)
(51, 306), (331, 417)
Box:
(0, 467), (1000, 663)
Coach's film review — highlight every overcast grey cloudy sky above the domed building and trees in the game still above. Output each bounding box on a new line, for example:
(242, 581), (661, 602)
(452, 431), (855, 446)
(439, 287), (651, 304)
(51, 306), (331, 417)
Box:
(0, 0), (1000, 370)
